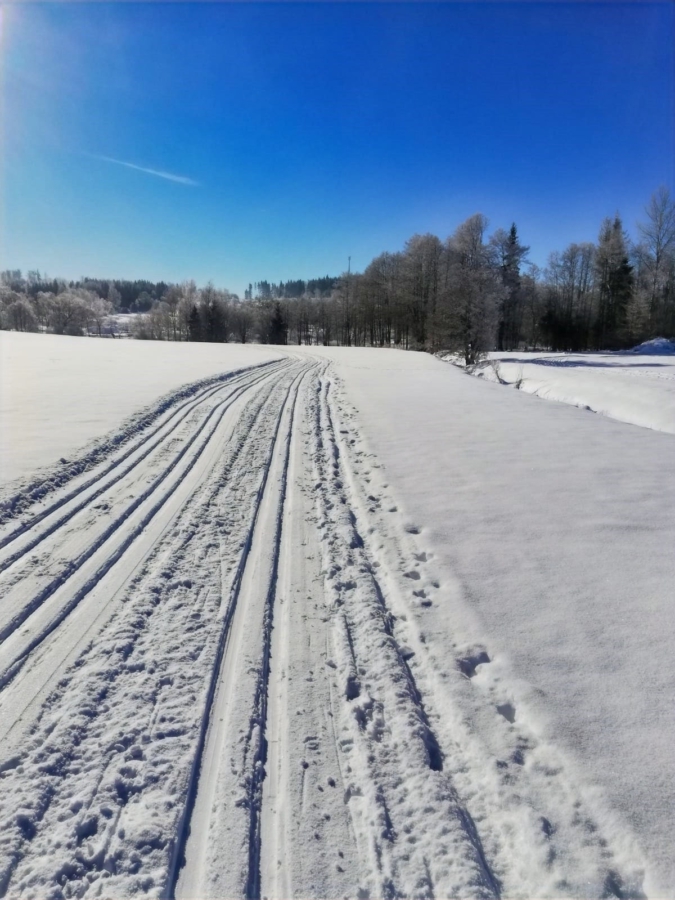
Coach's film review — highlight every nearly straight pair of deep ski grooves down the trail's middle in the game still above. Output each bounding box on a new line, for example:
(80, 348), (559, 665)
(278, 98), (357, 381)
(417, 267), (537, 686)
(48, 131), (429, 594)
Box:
(163, 367), (309, 898)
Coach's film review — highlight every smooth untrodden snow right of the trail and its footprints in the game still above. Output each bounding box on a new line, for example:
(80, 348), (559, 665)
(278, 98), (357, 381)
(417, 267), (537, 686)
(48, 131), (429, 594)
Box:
(316, 350), (675, 897)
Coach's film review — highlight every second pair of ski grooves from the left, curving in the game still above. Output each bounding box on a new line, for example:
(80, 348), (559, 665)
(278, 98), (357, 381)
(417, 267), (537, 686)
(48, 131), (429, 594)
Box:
(0, 358), (294, 689)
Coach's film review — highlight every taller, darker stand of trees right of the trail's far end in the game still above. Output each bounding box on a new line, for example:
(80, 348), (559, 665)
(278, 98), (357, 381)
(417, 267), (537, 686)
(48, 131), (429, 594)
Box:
(246, 187), (675, 363)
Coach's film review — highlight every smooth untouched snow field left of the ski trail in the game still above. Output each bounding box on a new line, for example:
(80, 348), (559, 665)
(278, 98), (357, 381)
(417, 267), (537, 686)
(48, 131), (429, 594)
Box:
(0, 331), (282, 484)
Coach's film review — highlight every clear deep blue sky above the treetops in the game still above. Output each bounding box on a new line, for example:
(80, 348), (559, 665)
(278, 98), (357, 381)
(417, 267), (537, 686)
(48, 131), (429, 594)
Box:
(0, 0), (675, 292)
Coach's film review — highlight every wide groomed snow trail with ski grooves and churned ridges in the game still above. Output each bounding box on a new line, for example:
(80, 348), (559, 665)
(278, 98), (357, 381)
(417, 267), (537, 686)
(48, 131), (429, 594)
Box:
(0, 352), (646, 900)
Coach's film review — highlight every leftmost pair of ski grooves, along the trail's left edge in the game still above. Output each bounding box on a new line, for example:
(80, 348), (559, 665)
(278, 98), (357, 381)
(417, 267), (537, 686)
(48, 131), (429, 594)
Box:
(0, 361), (288, 568)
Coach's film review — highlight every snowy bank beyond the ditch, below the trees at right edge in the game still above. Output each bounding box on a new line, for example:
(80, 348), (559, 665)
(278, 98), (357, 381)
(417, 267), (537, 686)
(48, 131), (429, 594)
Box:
(441, 338), (675, 434)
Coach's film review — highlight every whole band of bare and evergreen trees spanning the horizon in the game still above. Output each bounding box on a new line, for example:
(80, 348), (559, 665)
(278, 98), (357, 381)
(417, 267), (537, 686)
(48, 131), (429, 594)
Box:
(0, 187), (675, 363)
